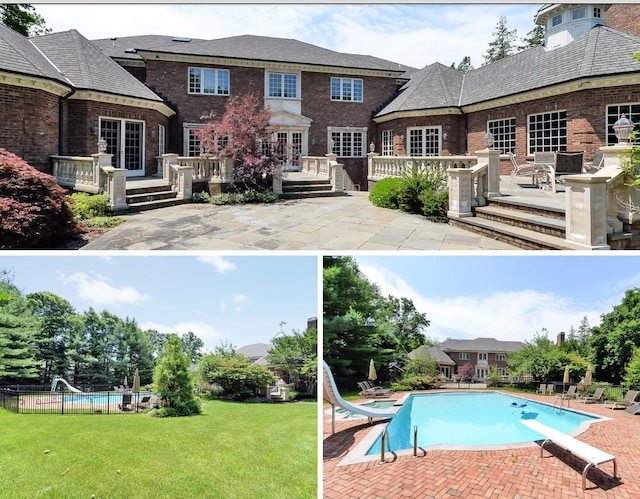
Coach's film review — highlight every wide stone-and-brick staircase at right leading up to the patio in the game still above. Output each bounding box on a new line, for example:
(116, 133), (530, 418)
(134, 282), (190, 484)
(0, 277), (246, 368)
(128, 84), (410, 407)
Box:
(450, 196), (630, 250)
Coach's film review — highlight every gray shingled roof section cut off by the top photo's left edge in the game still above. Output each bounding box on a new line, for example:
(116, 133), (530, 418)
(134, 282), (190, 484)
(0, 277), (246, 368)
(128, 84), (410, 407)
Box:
(0, 24), (69, 86)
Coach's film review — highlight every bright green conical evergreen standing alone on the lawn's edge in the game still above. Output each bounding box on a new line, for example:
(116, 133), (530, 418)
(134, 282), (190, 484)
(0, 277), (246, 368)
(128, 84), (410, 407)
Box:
(153, 334), (202, 416)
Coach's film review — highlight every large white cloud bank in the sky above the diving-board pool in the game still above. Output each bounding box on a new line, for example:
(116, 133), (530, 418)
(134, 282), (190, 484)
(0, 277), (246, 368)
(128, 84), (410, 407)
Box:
(358, 264), (601, 341)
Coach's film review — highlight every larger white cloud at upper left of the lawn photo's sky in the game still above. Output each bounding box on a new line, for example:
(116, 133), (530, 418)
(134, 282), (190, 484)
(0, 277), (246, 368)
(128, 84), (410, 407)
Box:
(59, 272), (150, 306)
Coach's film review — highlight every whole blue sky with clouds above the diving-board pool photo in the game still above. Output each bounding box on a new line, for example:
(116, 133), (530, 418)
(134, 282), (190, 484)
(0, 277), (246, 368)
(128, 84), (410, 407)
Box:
(356, 253), (640, 341)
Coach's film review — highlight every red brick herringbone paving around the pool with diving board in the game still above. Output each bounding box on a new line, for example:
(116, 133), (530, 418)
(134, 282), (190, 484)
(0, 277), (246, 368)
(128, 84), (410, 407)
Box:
(323, 394), (640, 499)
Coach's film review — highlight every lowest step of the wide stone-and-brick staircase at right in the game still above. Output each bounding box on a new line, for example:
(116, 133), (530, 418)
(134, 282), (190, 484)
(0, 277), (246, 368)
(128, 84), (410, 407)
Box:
(450, 217), (580, 250)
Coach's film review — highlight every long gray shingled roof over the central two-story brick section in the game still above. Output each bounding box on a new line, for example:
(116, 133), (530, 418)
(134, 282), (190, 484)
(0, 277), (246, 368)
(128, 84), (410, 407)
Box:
(95, 35), (411, 73)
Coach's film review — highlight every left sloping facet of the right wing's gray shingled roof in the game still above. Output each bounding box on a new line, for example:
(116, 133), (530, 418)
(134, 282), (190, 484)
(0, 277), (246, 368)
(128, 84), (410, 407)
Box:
(378, 62), (464, 116)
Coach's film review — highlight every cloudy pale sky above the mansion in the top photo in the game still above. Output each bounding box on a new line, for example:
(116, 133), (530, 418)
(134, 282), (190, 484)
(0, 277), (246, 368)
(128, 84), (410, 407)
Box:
(35, 3), (543, 68)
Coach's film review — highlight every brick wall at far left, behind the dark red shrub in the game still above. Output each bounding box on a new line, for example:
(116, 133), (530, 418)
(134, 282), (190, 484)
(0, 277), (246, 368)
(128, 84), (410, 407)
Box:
(0, 84), (59, 173)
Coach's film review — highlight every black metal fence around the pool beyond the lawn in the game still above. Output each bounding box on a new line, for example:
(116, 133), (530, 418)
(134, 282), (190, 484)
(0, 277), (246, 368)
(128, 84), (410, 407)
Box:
(0, 387), (157, 414)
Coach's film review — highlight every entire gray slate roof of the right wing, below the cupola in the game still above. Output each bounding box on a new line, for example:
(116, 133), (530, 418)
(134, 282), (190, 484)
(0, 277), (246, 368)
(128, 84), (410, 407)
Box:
(376, 26), (640, 117)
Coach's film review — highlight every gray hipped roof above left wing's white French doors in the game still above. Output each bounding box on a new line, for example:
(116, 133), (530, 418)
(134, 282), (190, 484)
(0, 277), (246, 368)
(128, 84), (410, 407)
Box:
(31, 30), (162, 102)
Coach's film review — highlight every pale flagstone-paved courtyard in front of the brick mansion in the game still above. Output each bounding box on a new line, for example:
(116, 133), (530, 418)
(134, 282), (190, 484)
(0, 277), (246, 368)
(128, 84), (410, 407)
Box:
(82, 192), (519, 251)
